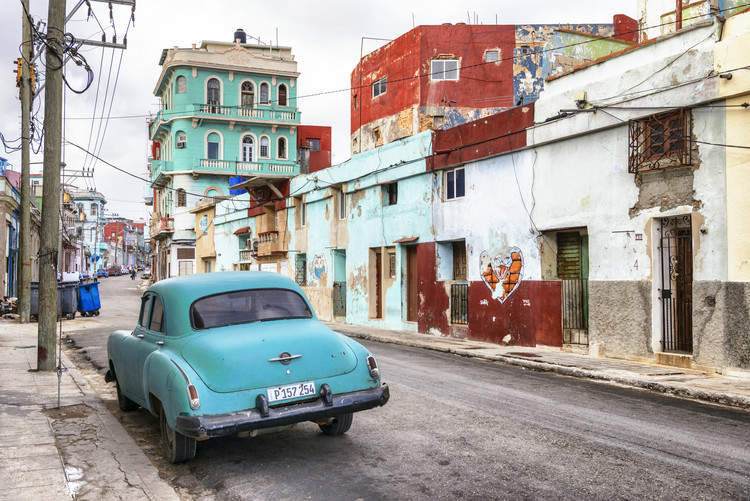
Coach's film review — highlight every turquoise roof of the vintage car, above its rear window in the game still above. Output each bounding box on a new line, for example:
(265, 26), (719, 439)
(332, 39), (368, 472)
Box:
(147, 271), (314, 329)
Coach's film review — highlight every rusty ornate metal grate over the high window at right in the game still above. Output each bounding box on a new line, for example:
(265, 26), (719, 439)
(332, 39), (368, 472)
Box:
(628, 109), (692, 174)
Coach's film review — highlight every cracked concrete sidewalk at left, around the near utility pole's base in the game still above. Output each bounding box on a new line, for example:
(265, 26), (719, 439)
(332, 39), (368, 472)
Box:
(0, 319), (179, 501)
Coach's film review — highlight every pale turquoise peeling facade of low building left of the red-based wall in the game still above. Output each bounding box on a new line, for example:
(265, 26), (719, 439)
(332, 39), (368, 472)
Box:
(289, 132), (433, 329)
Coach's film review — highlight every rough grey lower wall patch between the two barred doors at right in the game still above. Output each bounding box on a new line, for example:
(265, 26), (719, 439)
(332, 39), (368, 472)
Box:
(589, 280), (654, 358)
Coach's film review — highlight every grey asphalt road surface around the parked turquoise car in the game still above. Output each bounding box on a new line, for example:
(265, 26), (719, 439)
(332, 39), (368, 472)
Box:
(68, 277), (750, 500)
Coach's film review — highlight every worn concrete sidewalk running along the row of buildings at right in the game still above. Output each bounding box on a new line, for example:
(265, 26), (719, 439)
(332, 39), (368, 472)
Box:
(325, 322), (750, 409)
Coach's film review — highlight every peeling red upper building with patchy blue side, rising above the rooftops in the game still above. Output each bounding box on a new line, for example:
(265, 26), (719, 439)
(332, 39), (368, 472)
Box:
(350, 24), (627, 154)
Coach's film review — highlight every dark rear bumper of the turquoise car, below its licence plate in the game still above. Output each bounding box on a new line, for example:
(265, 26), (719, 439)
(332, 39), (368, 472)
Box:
(175, 384), (390, 438)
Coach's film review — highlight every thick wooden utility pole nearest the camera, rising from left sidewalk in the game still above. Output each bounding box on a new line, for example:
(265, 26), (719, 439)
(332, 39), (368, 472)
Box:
(37, 0), (65, 371)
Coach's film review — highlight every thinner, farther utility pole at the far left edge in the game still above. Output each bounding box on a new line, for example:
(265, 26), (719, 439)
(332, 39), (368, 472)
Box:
(18, 0), (34, 324)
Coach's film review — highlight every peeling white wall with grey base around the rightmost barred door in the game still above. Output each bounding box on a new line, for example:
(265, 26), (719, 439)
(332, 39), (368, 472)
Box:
(529, 15), (750, 368)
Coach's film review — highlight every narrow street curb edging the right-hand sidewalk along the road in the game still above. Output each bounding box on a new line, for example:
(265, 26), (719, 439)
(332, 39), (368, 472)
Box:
(334, 328), (750, 410)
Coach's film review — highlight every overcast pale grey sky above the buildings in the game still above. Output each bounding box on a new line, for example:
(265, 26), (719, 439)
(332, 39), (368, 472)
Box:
(0, 0), (637, 220)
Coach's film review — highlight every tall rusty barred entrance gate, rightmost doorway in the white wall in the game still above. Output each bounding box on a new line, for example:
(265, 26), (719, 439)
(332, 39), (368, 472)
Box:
(659, 214), (693, 353)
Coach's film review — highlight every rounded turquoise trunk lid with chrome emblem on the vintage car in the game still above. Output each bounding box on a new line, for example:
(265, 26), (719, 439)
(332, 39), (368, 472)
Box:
(182, 319), (357, 393)
